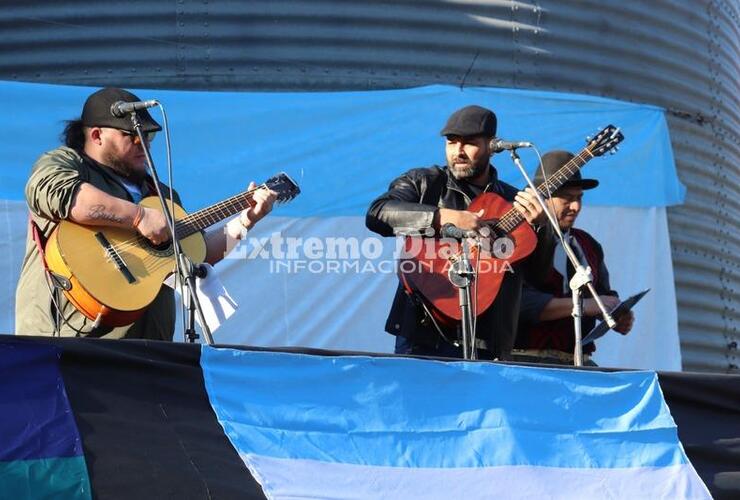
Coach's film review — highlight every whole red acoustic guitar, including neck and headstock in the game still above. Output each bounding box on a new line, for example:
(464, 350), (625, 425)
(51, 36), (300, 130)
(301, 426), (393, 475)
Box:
(398, 125), (624, 325)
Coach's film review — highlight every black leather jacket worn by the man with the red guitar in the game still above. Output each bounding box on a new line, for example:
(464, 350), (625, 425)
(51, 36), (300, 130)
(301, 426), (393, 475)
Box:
(365, 166), (553, 359)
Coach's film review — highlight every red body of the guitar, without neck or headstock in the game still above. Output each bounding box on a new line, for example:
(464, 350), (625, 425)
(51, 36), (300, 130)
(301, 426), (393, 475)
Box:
(399, 193), (537, 326)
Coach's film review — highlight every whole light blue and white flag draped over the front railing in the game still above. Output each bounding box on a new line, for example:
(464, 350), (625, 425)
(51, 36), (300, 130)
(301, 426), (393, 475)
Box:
(201, 346), (710, 500)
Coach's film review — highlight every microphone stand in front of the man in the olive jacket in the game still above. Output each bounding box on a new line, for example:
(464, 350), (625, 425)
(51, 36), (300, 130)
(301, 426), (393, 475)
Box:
(129, 111), (213, 344)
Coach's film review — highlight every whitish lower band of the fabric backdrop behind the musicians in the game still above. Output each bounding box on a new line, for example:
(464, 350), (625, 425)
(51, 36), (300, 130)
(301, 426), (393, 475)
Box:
(0, 202), (681, 370)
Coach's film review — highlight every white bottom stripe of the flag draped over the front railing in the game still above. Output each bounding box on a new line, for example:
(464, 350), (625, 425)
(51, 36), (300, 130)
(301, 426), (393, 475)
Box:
(243, 455), (709, 500)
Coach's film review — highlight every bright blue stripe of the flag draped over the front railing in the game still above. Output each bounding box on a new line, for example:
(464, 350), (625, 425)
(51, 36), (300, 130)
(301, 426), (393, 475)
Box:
(201, 347), (687, 468)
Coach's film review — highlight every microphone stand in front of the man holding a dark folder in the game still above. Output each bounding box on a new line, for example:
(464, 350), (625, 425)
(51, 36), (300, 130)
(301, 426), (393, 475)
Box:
(511, 147), (617, 366)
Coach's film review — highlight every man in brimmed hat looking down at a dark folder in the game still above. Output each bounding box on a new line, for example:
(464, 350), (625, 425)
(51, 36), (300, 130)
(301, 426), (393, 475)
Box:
(513, 151), (634, 365)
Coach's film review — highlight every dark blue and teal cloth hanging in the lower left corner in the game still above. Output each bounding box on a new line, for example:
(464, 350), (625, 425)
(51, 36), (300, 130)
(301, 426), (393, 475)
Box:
(0, 340), (91, 499)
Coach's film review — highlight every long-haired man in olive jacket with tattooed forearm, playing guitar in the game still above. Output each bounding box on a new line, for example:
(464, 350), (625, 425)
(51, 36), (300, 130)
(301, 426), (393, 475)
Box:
(15, 88), (275, 340)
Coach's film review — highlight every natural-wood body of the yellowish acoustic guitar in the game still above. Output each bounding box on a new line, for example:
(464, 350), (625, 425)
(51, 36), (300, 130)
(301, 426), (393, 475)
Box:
(45, 197), (206, 327)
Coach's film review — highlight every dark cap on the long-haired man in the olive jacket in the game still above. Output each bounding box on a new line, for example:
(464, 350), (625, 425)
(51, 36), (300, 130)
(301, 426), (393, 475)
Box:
(81, 87), (162, 132)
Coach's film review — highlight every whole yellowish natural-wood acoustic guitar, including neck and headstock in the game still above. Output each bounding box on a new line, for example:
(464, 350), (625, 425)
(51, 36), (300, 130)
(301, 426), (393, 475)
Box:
(45, 173), (300, 327)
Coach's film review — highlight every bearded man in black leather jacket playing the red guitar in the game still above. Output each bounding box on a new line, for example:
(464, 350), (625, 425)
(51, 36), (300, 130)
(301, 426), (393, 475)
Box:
(366, 106), (552, 359)
